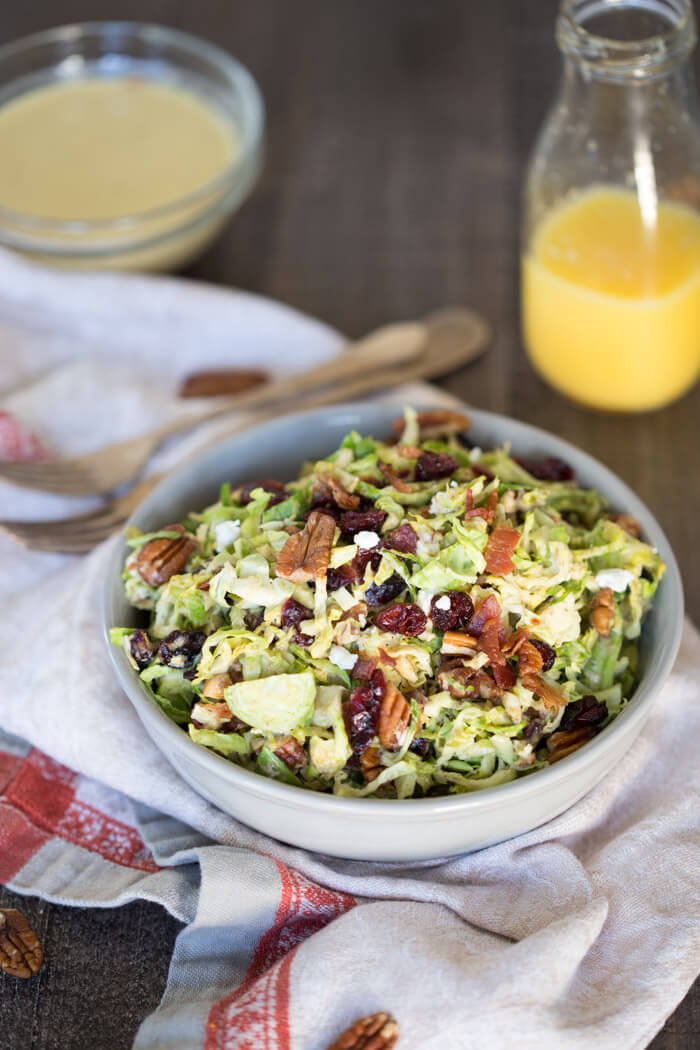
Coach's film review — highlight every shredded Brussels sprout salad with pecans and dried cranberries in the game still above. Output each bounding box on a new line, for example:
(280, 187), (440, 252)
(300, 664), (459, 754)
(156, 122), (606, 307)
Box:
(110, 410), (664, 799)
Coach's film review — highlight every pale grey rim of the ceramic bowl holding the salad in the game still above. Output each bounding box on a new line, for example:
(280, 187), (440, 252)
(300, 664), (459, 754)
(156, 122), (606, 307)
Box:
(102, 398), (684, 822)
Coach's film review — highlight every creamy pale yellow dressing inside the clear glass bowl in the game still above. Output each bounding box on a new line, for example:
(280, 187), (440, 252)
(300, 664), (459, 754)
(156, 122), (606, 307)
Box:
(0, 77), (239, 219)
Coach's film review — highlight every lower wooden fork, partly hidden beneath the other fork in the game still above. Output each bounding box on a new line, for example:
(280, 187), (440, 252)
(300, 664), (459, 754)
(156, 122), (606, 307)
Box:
(0, 311), (490, 554)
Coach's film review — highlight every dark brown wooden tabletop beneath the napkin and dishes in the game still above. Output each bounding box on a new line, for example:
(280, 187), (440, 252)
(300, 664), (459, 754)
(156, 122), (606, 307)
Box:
(0, 0), (700, 1050)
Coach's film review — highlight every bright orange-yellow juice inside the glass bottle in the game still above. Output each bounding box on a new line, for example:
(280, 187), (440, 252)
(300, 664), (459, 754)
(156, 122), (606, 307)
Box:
(523, 187), (700, 412)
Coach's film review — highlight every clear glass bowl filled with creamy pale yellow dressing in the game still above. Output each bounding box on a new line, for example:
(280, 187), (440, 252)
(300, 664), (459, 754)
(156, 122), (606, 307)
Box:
(0, 22), (264, 271)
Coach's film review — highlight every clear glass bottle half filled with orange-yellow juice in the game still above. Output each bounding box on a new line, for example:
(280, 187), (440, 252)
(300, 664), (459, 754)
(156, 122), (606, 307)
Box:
(522, 0), (700, 412)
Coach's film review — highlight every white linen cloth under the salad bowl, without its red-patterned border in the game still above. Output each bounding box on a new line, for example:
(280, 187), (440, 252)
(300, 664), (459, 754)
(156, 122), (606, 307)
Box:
(0, 247), (700, 1050)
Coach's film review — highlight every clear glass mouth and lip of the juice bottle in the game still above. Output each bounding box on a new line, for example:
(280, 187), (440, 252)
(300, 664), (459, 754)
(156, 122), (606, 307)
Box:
(556, 0), (696, 84)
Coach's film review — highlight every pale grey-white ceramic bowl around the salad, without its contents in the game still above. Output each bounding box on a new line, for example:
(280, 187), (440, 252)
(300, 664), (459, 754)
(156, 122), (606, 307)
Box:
(103, 403), (683, 861)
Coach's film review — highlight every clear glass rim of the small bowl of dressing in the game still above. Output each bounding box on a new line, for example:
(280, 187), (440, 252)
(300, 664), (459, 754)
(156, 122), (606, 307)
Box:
(0, 19), (266, 237)
